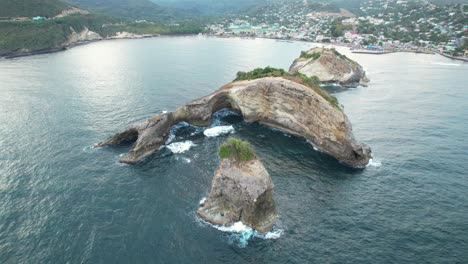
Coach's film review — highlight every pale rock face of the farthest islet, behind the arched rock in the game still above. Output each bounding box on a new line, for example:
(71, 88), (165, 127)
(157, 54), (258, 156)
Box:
(289, 48), (369, 86)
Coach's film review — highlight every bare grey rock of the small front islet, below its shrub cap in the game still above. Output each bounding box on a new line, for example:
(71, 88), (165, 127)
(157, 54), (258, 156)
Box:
(197, 159), (277, 233)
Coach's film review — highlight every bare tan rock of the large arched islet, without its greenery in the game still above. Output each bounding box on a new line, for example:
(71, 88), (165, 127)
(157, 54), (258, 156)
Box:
(97, 77), (371, 167)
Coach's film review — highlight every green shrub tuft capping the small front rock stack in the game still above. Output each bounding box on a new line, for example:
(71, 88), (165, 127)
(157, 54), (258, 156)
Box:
(219, 138), (257, 162)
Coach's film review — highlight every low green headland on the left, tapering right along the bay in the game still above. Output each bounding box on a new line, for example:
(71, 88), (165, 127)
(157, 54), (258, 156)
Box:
(0, 14), (202, 57)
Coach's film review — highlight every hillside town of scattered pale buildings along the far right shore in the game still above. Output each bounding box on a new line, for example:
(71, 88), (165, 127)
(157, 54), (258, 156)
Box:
(206, 0), (468, 61)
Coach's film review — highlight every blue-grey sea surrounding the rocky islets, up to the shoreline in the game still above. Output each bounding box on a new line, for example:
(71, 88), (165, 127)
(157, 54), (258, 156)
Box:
(0, 37), (468, 264)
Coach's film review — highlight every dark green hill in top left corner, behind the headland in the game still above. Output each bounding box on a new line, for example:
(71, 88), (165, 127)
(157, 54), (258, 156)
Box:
(0, 0), (70, 17)
